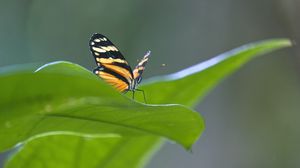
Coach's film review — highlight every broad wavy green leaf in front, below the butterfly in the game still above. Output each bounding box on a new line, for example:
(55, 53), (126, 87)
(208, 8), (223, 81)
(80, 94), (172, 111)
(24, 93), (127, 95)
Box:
(0, 63), (204, 151)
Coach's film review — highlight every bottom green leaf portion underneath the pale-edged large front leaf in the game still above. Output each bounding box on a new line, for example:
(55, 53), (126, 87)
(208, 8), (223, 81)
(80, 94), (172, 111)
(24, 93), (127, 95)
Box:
(6, 135), (161, 168)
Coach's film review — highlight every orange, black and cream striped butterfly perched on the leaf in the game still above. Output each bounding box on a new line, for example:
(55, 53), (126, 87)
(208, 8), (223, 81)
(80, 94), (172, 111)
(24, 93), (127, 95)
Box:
(89, 33), (151, 100)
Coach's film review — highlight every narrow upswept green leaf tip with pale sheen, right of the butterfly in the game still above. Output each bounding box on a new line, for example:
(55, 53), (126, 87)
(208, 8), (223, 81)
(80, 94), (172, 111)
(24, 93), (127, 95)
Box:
(140, 39), (291, 106)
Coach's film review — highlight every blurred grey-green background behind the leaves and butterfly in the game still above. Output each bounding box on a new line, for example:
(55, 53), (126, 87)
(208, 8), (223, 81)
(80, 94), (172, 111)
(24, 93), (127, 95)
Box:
(0, 0), (300, 168)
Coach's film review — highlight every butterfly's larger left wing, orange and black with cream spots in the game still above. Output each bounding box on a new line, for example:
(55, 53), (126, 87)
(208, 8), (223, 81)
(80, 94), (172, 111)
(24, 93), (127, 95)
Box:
(89, 34), (133, 92)
